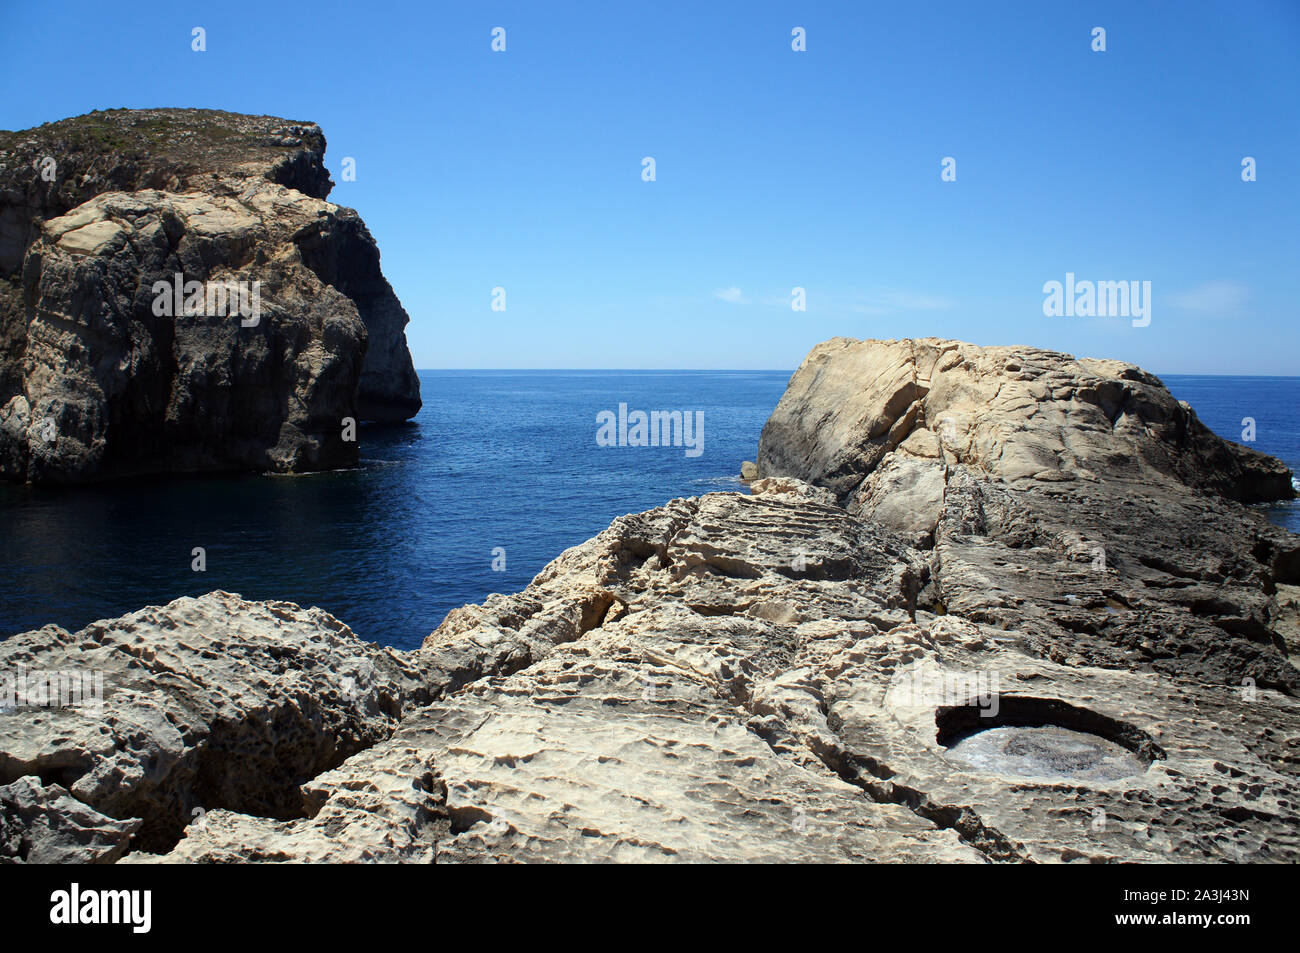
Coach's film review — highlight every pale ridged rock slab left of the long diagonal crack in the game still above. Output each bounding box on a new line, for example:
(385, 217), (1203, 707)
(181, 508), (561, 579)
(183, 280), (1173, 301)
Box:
(133, 484), (984, 862)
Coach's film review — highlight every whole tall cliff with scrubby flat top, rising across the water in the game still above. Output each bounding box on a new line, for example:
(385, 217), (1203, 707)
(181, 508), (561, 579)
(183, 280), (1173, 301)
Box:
(0, 109), (420, 482)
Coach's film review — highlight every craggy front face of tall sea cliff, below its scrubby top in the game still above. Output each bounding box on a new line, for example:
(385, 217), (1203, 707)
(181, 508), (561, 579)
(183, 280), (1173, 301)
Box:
(9, 188), (365, 482)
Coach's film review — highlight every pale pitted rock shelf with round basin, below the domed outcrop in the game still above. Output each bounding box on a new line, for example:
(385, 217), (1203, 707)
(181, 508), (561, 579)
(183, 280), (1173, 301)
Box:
(130, 480), (1300, 863)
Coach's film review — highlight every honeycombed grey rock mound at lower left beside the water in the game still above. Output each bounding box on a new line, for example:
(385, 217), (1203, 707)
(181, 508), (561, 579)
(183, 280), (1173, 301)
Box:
(0, 592), (430, 850)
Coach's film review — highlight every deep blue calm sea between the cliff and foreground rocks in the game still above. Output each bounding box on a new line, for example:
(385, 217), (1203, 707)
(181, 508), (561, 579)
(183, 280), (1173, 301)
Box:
(0, 371), (1300, 647)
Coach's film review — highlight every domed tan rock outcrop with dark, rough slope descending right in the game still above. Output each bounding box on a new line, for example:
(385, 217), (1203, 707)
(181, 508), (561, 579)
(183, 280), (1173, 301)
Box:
(759, 338), (1300, 692)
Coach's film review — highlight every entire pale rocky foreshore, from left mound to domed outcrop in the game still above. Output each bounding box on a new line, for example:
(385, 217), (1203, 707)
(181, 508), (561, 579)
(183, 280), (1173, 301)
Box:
(0, 339), (1300, 863)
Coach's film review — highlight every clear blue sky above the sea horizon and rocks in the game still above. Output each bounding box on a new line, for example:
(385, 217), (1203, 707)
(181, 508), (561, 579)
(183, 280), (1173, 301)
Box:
(0, 0), (1300, 374)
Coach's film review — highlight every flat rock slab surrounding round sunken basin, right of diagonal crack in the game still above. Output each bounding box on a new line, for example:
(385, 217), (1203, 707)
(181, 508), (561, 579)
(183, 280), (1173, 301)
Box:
(781, 614), (1300, 862)
